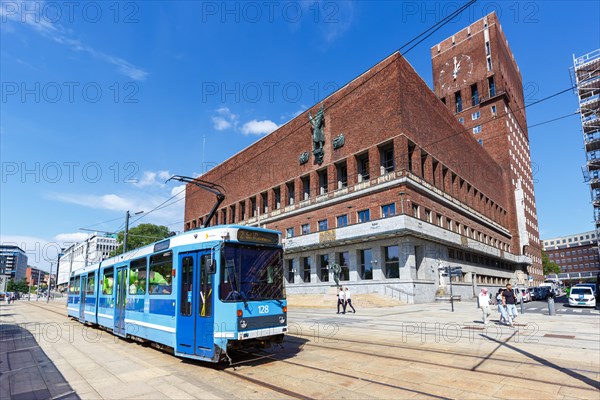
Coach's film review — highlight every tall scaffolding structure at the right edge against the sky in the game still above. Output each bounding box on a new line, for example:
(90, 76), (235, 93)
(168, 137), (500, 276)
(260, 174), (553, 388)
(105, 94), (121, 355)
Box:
(571, 49), (600, 247)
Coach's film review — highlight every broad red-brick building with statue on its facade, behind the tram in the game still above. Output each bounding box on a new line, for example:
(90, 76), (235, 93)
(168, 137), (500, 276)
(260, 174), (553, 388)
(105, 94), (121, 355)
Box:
(185, 13), (537, 302)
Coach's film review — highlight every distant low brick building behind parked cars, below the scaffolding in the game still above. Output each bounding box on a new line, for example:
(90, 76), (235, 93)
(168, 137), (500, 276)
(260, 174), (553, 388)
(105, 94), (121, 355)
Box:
(543, 231), (600, 273)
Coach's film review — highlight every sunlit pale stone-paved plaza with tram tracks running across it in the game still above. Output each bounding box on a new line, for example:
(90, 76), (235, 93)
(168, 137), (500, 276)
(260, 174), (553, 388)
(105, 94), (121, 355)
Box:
(0, 301), (600, 400)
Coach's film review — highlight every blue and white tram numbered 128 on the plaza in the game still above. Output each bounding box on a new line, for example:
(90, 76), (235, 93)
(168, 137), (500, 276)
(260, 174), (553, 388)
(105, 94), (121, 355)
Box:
(67, 225), (287, 362)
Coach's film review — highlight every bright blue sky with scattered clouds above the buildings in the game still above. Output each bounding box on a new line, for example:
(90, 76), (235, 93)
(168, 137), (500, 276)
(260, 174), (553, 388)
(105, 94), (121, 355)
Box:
(0, 1), (600, 267)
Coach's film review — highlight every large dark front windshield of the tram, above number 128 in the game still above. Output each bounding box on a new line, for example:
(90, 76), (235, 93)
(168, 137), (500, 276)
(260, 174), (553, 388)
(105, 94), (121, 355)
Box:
(219, 244), (283, 301)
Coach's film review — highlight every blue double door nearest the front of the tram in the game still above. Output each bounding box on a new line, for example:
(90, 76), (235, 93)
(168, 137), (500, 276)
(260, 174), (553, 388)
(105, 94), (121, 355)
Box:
(177, 251), (214, 357)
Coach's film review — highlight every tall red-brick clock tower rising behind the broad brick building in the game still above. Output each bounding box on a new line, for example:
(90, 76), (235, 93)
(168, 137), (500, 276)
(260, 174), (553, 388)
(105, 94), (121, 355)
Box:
(431, 13), (543, 283)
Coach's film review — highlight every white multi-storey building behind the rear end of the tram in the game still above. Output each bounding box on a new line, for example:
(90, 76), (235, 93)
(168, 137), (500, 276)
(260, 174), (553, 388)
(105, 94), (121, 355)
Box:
(57, 234), (119, 285)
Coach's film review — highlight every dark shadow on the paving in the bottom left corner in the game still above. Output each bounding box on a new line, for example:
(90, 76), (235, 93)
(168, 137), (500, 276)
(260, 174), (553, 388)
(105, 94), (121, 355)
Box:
(0, 324), (79, 400)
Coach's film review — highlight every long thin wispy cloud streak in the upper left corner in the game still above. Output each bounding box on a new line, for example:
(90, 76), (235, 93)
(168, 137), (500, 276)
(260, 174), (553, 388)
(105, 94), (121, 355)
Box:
(0, 1), (148, 81)
